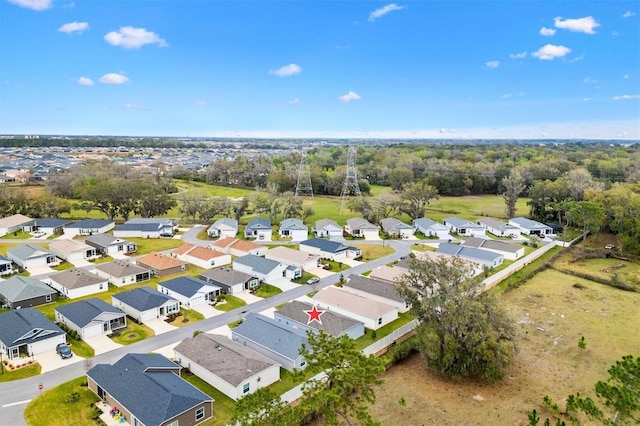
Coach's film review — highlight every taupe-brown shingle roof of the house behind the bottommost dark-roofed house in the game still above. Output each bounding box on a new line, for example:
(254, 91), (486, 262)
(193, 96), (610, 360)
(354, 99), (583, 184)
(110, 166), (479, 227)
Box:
(174, 333), (278, 386)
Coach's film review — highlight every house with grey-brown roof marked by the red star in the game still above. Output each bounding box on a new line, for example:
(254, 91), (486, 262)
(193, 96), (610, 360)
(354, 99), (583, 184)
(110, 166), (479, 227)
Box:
(273, 300), (364, 339)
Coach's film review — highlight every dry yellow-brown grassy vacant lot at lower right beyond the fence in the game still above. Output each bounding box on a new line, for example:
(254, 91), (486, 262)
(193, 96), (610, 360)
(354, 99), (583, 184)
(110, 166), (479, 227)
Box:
(373, 271), (640, 425)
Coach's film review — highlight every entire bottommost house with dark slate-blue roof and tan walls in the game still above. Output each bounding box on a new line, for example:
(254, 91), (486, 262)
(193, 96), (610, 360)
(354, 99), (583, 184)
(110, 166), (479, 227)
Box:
(87, 353), (213, 426)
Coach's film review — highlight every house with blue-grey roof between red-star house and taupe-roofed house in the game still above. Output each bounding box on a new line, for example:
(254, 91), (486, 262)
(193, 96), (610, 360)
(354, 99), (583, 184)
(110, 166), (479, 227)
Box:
(231, 312), (309, 370)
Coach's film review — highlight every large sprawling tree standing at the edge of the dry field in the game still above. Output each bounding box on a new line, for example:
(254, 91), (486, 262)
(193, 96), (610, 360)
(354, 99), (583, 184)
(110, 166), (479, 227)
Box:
(399, 258), (515, 382)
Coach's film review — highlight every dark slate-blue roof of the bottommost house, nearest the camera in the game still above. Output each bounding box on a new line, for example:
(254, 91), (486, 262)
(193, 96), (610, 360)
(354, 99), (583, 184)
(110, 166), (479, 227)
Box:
(87, 354), (213, 425)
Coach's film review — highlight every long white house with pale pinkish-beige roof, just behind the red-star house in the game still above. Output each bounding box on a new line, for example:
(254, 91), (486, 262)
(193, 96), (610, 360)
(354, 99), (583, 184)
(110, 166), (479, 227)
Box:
(313, 286), (398, 330)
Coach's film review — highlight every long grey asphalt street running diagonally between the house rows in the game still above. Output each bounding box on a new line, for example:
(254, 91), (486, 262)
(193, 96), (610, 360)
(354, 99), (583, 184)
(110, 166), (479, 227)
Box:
(0, 227), (413, 426)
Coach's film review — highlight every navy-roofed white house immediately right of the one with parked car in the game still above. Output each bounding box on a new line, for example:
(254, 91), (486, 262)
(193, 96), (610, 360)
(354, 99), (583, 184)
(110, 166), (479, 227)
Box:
(54, 298), (127, 340)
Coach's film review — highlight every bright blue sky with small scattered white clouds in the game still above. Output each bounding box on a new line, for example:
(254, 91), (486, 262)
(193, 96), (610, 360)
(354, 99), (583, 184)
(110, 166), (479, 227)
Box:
(0, 0), (640, 139)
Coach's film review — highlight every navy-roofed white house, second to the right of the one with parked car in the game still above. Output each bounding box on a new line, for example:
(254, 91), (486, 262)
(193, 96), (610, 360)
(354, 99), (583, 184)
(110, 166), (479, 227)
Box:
(111, 287), (180, 324)
